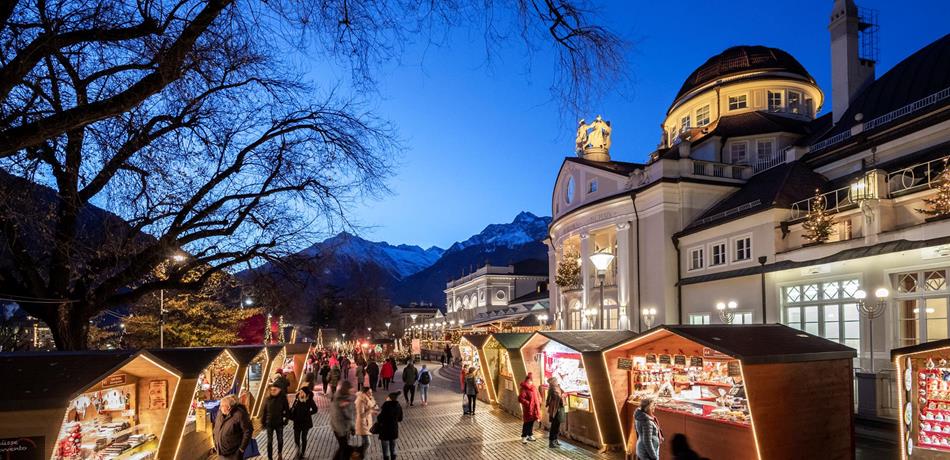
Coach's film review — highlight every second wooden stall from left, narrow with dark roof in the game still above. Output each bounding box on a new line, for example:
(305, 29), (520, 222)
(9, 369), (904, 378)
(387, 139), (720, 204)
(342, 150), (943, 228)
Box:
(152, 347), (238, 459)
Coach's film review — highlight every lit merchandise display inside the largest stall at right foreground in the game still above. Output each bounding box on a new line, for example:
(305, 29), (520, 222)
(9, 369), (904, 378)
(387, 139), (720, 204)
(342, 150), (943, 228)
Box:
(628, 355), (749, 426)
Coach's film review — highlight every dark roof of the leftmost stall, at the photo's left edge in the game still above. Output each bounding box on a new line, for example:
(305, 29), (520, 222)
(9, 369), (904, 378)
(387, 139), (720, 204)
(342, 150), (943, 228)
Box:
(0, 350), (134, 411)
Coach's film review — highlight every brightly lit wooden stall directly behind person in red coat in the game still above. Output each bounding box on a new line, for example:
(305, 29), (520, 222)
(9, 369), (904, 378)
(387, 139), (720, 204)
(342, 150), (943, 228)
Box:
(515, 330), (636, 448)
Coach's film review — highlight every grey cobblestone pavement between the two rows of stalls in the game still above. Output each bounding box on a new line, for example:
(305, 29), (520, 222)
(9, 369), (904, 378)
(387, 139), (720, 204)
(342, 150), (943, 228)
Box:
(242, 363), (623, 460)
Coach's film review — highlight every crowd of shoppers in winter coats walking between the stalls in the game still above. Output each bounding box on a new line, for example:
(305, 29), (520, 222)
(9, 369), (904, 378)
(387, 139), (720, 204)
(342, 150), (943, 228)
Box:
(212, 344), (712, 460)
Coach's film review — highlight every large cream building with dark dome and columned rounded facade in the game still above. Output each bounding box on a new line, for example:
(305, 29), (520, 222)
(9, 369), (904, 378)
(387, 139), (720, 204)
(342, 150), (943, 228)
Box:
(548, 0), (950, 415)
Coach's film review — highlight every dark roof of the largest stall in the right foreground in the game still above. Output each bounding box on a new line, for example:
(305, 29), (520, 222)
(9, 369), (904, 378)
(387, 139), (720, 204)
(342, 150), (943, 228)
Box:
(641, 324), (857, 364)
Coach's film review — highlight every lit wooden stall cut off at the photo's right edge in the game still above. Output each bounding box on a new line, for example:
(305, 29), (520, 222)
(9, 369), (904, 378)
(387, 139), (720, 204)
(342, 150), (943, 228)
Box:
(891, 339), (950, 460)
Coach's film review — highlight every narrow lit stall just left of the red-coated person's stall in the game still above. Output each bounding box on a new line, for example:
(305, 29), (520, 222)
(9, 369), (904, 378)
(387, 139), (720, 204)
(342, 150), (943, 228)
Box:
(482, 332), (531, 417)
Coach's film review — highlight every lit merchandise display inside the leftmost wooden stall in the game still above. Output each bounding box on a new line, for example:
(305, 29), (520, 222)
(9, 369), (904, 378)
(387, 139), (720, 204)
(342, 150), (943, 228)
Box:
(53, 382), (164, 460)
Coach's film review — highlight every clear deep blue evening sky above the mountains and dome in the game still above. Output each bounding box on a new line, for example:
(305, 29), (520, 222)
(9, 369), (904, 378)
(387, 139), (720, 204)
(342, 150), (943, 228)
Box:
(310, 0), (950, 252)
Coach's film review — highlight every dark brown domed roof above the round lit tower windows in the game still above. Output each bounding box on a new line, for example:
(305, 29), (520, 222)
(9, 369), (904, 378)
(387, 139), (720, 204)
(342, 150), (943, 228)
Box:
(673, 45), (815, 105)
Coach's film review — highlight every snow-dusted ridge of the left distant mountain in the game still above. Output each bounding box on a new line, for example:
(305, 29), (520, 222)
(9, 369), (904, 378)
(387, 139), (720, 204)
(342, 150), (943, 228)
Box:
(312, 232), (445, 279)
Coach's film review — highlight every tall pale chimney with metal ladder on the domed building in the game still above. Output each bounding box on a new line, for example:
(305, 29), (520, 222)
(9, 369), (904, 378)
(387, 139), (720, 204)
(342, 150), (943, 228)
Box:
(828, 0), (877, 123)
